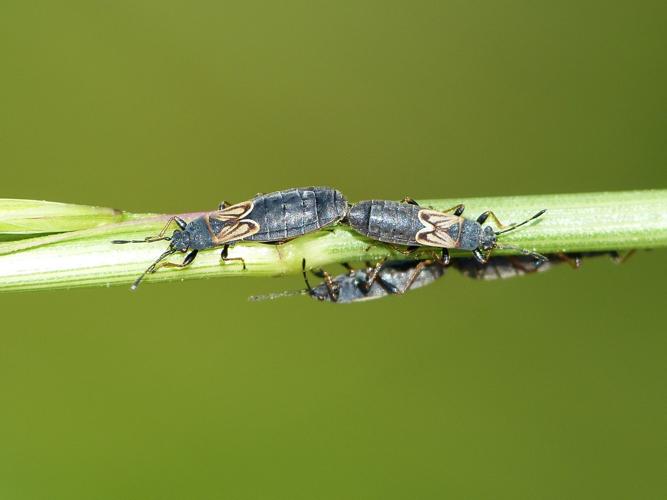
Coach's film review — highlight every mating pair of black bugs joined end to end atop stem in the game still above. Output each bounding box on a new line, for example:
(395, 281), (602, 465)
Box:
(113, 187), (547, 290)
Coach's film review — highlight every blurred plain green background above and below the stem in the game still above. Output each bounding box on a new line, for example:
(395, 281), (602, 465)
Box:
(0, 0), (667, 500)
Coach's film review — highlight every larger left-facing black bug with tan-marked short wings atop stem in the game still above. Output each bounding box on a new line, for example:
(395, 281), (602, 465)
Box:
(112, 187), (348, 290)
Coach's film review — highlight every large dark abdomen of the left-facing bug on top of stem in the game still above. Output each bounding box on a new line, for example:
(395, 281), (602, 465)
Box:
(246, 187), (347, 241)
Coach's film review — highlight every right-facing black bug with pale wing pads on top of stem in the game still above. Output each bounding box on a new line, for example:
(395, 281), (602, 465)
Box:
(345, 198), (546, 265)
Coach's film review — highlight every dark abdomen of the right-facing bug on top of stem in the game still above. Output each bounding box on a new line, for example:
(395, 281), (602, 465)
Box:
(347, 200), (424, 246)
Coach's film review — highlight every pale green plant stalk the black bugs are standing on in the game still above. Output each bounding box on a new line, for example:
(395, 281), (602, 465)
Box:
(0, 190), (667, 291)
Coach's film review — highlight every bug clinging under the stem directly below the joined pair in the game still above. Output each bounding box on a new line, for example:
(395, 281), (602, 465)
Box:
(250, 259), (446, 304)
